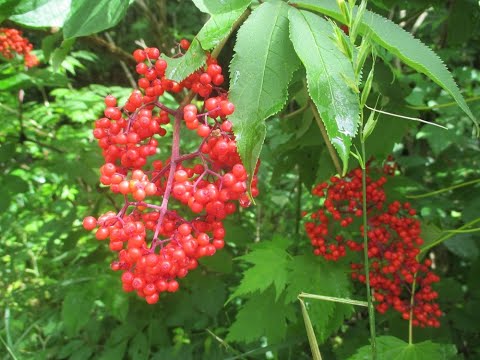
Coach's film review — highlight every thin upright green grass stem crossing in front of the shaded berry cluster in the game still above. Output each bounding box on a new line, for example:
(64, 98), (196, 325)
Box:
(360, 136), (377, 360)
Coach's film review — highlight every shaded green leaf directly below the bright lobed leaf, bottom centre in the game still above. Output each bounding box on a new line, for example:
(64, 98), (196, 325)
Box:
(226, 287), (291, 344)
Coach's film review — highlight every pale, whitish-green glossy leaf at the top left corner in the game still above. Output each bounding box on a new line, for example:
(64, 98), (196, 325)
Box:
(9, 0), (72, 27)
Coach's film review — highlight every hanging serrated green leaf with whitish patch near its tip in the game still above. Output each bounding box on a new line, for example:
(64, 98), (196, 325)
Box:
(288, 8), (360, 172)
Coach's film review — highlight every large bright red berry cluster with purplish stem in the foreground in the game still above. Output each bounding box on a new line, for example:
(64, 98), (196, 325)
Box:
(83, 41), (258, 304)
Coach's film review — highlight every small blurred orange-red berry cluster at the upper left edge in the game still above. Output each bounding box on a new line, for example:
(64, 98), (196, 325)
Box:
(0, 28), (38, 67)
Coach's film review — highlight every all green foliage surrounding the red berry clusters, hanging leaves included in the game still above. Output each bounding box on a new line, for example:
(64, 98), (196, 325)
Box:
(0, 0), (480, 359)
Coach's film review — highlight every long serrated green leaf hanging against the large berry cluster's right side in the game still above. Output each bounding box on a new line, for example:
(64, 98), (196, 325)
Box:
(230, 1), (299, 183)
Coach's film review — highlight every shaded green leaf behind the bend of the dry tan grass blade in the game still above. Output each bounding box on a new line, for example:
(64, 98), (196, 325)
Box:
(285, 254), (353, 342)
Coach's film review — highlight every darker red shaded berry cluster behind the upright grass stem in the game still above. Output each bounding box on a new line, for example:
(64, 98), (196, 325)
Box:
(305, 165), (442, 327)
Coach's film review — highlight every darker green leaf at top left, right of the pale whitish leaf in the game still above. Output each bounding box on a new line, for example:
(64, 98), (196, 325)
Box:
(63, 0), (129, 39)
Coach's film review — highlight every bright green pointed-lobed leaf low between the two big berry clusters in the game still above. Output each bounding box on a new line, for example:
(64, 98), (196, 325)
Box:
(229, 238), (289, 301)
